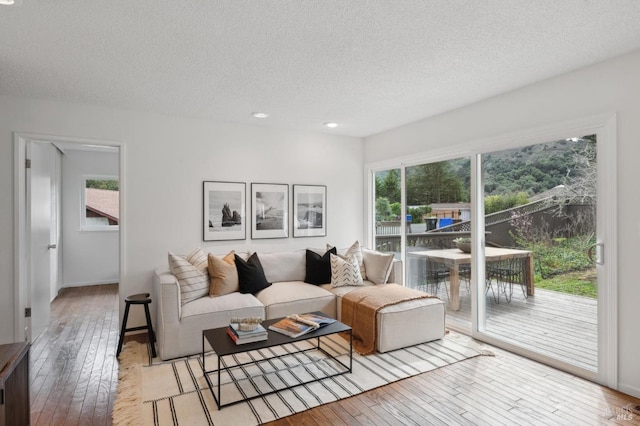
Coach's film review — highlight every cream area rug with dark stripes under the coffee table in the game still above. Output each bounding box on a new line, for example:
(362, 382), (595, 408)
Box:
(113, 333), (491, 425)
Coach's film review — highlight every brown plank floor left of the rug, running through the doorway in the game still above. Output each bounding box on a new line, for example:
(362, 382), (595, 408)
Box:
(30, 284), (119, 425)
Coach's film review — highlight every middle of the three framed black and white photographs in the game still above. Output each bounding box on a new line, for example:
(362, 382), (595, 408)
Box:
(251, 183), (289, 239)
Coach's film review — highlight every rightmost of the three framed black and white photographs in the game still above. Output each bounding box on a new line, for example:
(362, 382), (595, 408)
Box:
(293, 185), (327, 237)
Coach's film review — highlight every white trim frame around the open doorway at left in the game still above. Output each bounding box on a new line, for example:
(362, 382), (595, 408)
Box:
(13, 132), (126, 342)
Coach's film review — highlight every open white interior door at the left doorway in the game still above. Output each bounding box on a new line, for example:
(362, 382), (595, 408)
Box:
(27, 142), (58, 341)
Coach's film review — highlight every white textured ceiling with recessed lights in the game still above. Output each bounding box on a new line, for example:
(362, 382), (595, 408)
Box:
(0, 0), (640, 137)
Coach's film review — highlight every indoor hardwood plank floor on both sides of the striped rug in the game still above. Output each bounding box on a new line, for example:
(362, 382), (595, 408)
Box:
(31, 285), (640, 425)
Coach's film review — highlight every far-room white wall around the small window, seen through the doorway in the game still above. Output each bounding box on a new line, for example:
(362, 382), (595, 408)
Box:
(61, 149), (120, 287)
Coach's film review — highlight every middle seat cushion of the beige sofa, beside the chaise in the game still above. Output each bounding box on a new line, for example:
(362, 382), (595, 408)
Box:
(256, 281), (336, 319)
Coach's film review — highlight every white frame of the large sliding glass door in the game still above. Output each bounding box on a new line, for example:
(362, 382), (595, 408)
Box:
(364, 113), (618, 389)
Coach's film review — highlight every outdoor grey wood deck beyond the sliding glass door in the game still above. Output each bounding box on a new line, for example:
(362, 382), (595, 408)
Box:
(418, 283), (598, 371)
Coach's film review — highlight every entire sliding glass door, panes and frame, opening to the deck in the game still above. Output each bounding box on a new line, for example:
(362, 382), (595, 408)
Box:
(372, 119), (617, 387)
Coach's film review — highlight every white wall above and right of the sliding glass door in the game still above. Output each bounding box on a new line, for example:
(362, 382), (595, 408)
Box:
(364, 51), (640, 397)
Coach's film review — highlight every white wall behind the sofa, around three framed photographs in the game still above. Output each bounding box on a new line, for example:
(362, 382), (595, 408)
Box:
(0, 96), (363, 343)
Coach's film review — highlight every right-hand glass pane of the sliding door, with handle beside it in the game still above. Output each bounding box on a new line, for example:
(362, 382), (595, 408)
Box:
(479, 135), (598, 372)
